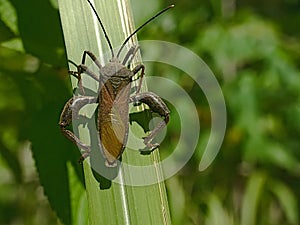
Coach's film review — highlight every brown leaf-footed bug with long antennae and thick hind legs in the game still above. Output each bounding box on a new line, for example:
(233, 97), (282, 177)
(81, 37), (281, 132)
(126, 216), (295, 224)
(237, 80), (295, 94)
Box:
(59, 0), (173, 167)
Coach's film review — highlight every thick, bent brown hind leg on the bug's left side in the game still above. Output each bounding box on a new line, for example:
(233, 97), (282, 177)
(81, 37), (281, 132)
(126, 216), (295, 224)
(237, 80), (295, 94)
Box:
(58, 96), (97, 161)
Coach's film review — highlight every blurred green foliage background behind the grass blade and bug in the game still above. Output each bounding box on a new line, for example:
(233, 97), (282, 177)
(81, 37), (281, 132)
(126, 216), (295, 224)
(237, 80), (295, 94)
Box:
(0, 0), (300, 225)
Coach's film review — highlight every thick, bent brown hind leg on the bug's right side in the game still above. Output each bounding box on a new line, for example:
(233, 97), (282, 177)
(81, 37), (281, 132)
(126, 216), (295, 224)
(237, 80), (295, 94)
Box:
(130, 92), (170, 151)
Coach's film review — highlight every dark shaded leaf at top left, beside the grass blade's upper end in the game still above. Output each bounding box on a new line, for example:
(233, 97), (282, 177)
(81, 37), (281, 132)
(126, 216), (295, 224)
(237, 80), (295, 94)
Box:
(7, 0), (66, 67)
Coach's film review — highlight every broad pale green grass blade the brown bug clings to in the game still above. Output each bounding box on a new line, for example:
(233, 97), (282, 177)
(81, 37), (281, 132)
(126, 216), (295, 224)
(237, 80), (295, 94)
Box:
(59, 0), (171, 225)
